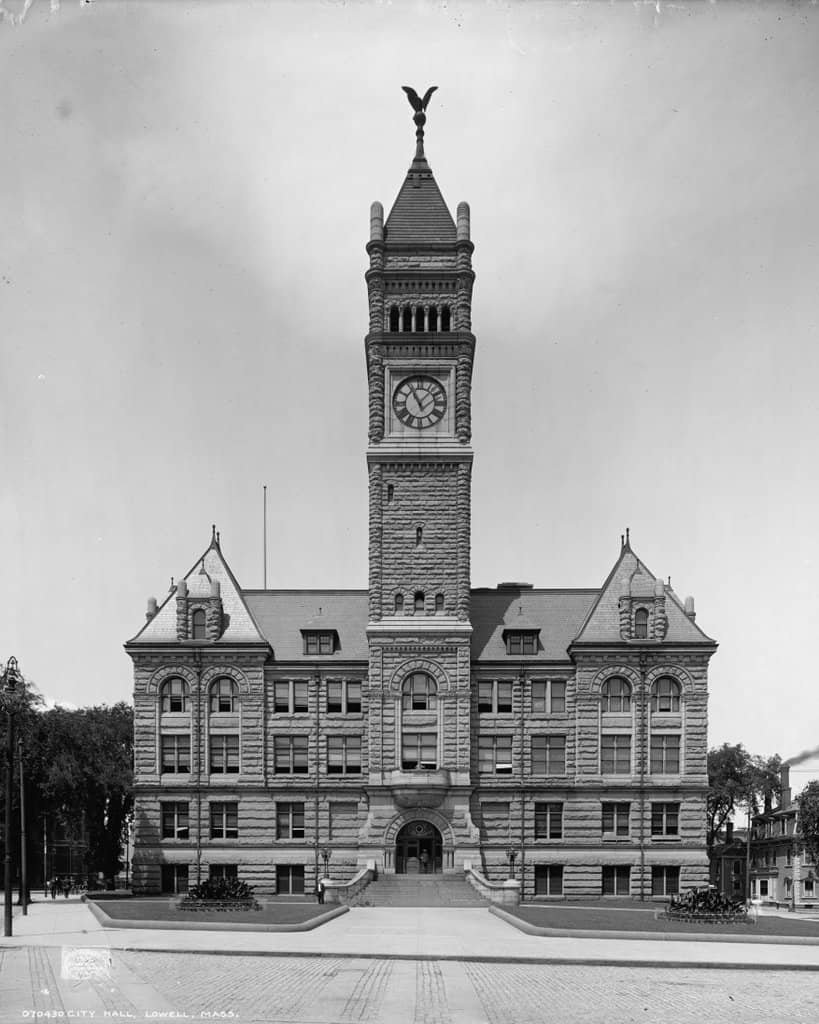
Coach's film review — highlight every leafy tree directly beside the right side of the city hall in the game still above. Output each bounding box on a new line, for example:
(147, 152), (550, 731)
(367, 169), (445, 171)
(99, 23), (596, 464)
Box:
(706, 743), (782, 852)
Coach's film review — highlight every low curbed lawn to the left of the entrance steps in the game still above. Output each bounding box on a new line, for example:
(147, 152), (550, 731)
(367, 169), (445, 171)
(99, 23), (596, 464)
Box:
(88, 896), (334, 928)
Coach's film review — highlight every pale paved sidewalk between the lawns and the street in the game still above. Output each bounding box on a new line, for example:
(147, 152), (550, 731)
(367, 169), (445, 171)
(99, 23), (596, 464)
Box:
(0, 899), (819, 971)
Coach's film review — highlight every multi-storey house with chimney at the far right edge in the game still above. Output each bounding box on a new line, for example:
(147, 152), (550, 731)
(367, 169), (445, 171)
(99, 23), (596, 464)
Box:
(750, 765), (819, 907)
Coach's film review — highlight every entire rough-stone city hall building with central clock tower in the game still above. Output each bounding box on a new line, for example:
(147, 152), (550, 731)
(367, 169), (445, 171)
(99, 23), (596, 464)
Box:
(126, 94), (717, 898)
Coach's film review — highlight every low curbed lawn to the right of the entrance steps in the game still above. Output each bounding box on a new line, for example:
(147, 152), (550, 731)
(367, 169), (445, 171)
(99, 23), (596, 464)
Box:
(508, 902), (819, 938)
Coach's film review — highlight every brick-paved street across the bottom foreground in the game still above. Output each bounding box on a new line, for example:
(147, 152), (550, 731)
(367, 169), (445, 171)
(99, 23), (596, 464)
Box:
(0, 946), (819, 1024)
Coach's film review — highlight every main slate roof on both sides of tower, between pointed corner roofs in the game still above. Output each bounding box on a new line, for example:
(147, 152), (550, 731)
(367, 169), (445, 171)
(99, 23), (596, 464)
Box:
(243, 590), (599, 664)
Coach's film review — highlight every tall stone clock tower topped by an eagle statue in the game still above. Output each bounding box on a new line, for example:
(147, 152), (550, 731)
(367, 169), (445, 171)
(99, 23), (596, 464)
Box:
(365, 88), (477, 871)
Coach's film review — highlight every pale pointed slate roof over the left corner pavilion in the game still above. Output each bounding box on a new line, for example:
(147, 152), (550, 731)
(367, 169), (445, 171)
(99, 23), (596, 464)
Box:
(128, 537), (265, 645)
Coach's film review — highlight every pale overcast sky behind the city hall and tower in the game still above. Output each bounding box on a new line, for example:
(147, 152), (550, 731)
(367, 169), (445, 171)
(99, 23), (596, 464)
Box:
(0, 0), (819, 770)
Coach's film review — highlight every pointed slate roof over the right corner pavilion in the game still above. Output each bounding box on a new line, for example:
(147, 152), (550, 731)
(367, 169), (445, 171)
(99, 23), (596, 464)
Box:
(573, 542), (716, 644)
